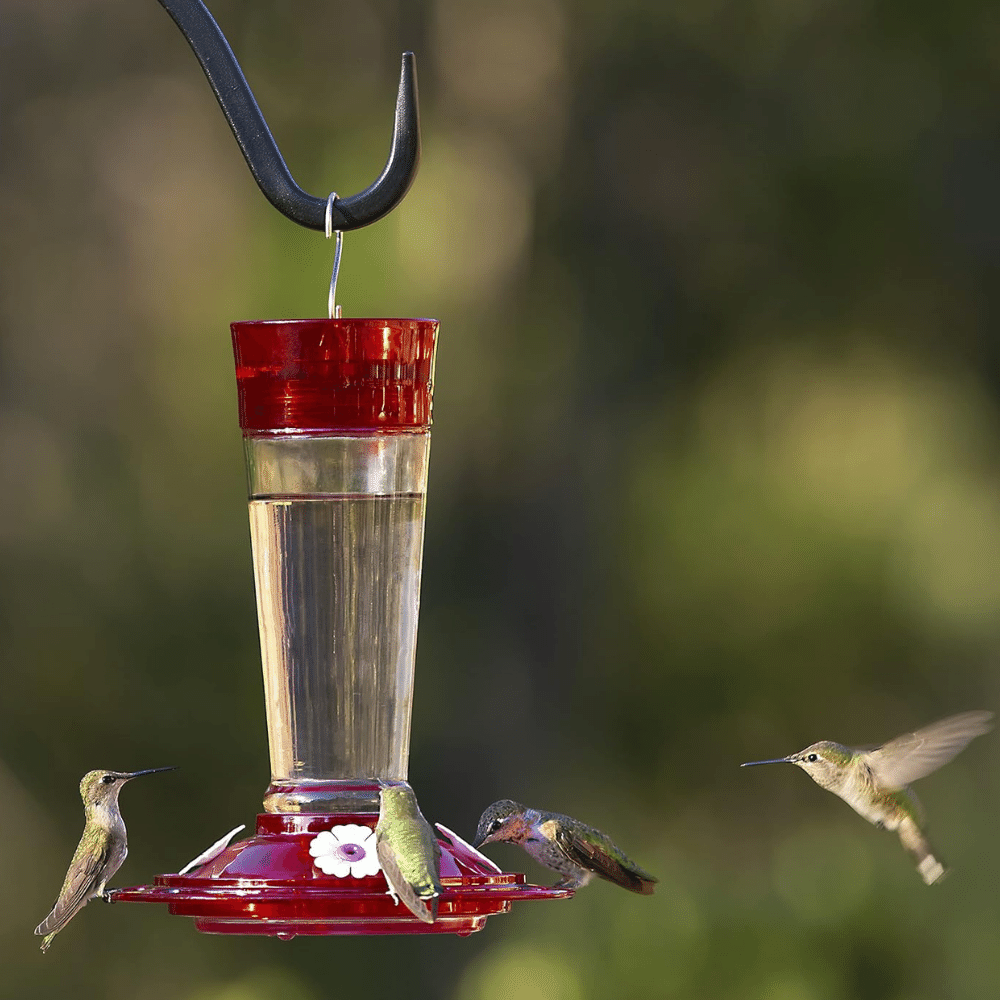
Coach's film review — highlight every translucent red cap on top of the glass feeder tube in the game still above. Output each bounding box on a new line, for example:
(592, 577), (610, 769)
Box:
(232, 319), (438, 437)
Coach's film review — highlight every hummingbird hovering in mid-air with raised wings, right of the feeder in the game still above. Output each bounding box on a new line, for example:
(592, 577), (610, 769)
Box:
(740, 712), (993, 885)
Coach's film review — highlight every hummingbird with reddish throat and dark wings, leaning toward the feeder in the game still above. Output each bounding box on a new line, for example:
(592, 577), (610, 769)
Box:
(472, 799), (659, 896)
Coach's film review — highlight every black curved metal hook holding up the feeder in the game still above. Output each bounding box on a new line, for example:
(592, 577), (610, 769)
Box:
(160, 0), (420, 230)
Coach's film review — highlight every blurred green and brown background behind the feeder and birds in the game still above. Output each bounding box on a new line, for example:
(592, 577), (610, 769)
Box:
(0, 0), (1000, 1000)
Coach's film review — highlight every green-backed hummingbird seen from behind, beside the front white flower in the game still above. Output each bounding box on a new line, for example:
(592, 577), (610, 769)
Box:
(375, 784), (441, 924)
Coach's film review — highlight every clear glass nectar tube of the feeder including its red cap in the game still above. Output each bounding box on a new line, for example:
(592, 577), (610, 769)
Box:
(233, 319), (438, 813)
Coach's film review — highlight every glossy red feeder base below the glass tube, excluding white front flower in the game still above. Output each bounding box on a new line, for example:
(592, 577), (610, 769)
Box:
(109, 813), (573, 940)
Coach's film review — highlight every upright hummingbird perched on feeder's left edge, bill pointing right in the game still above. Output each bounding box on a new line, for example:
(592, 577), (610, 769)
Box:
(35, 767), (174, 951)
